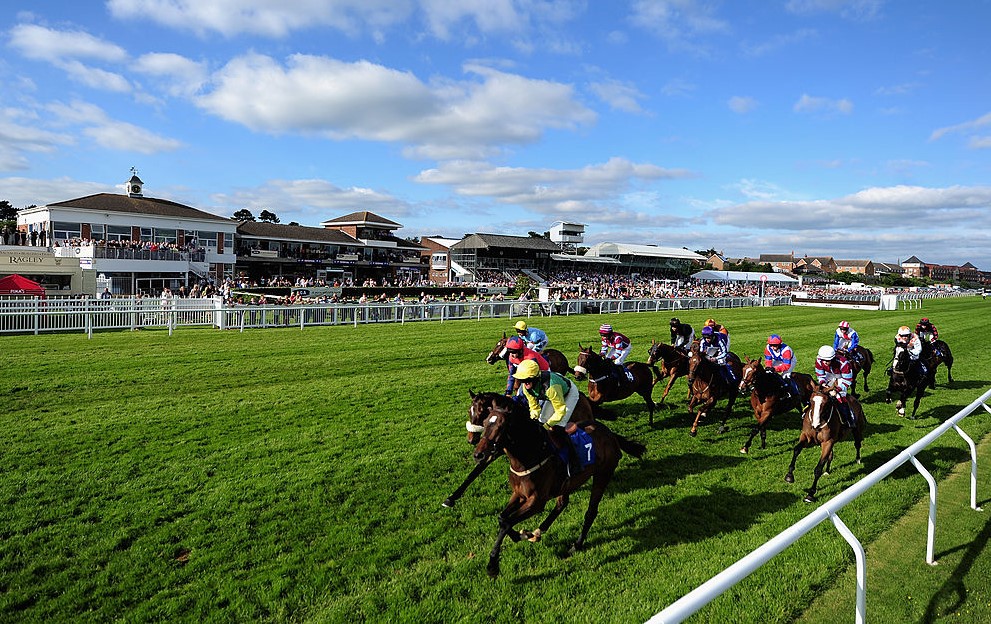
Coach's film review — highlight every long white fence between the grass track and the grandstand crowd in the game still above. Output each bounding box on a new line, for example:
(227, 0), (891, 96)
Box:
(0, 297), (789, 336)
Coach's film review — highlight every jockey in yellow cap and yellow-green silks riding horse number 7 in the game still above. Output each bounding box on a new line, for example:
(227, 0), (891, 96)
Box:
(513, 360), (581, 476)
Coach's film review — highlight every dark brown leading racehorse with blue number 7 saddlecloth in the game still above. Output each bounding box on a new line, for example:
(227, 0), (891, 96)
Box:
(475, 404), (647, 578)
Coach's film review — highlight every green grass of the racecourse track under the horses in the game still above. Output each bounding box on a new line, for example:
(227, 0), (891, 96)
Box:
(0, 298), (991, 622)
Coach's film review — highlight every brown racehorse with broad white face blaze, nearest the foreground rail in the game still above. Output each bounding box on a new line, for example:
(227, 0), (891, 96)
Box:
(785, 384), (867, 503)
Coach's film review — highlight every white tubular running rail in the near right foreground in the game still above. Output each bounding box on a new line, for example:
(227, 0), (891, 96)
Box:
(648, 390), (991, 624)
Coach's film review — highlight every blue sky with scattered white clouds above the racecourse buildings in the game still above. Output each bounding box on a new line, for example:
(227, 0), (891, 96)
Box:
(0, 0), (991, 270)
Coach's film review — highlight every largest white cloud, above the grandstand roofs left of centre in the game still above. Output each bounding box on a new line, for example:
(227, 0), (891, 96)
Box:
(197, 54), (595, 158)
